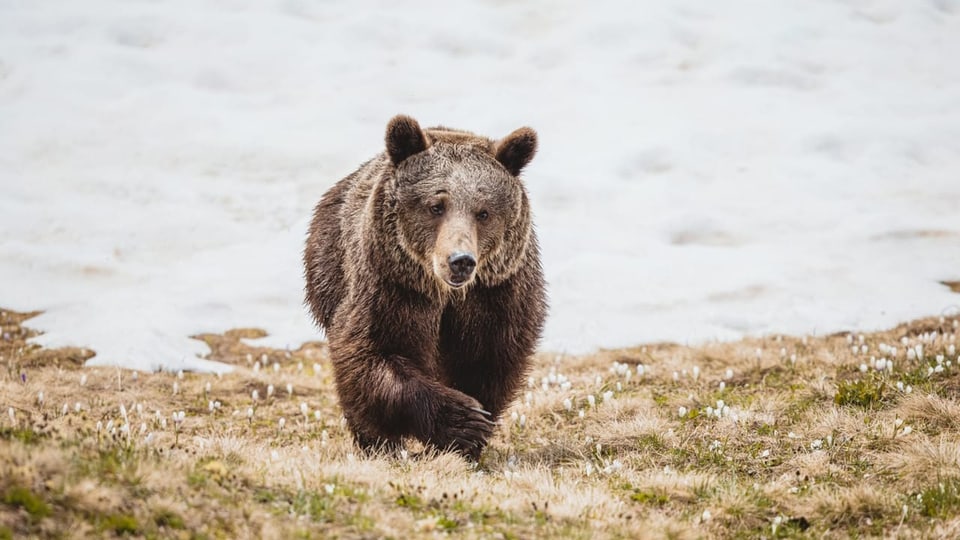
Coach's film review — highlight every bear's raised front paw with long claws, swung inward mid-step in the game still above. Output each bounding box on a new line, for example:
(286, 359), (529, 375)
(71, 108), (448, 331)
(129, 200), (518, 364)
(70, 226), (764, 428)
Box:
(430, 391), (497, 460)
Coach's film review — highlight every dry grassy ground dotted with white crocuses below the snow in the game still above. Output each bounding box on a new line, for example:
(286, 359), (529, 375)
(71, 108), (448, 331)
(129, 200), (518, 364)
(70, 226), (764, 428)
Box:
(0, 311), (960, 538)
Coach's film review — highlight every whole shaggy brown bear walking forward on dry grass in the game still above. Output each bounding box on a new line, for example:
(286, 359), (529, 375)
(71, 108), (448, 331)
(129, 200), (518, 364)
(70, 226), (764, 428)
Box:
(304, 115), (547, 459)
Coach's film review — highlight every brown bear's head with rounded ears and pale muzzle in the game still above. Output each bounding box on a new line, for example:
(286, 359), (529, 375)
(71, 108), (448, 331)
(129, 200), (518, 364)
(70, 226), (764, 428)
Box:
(386, 115), (537, 289)
